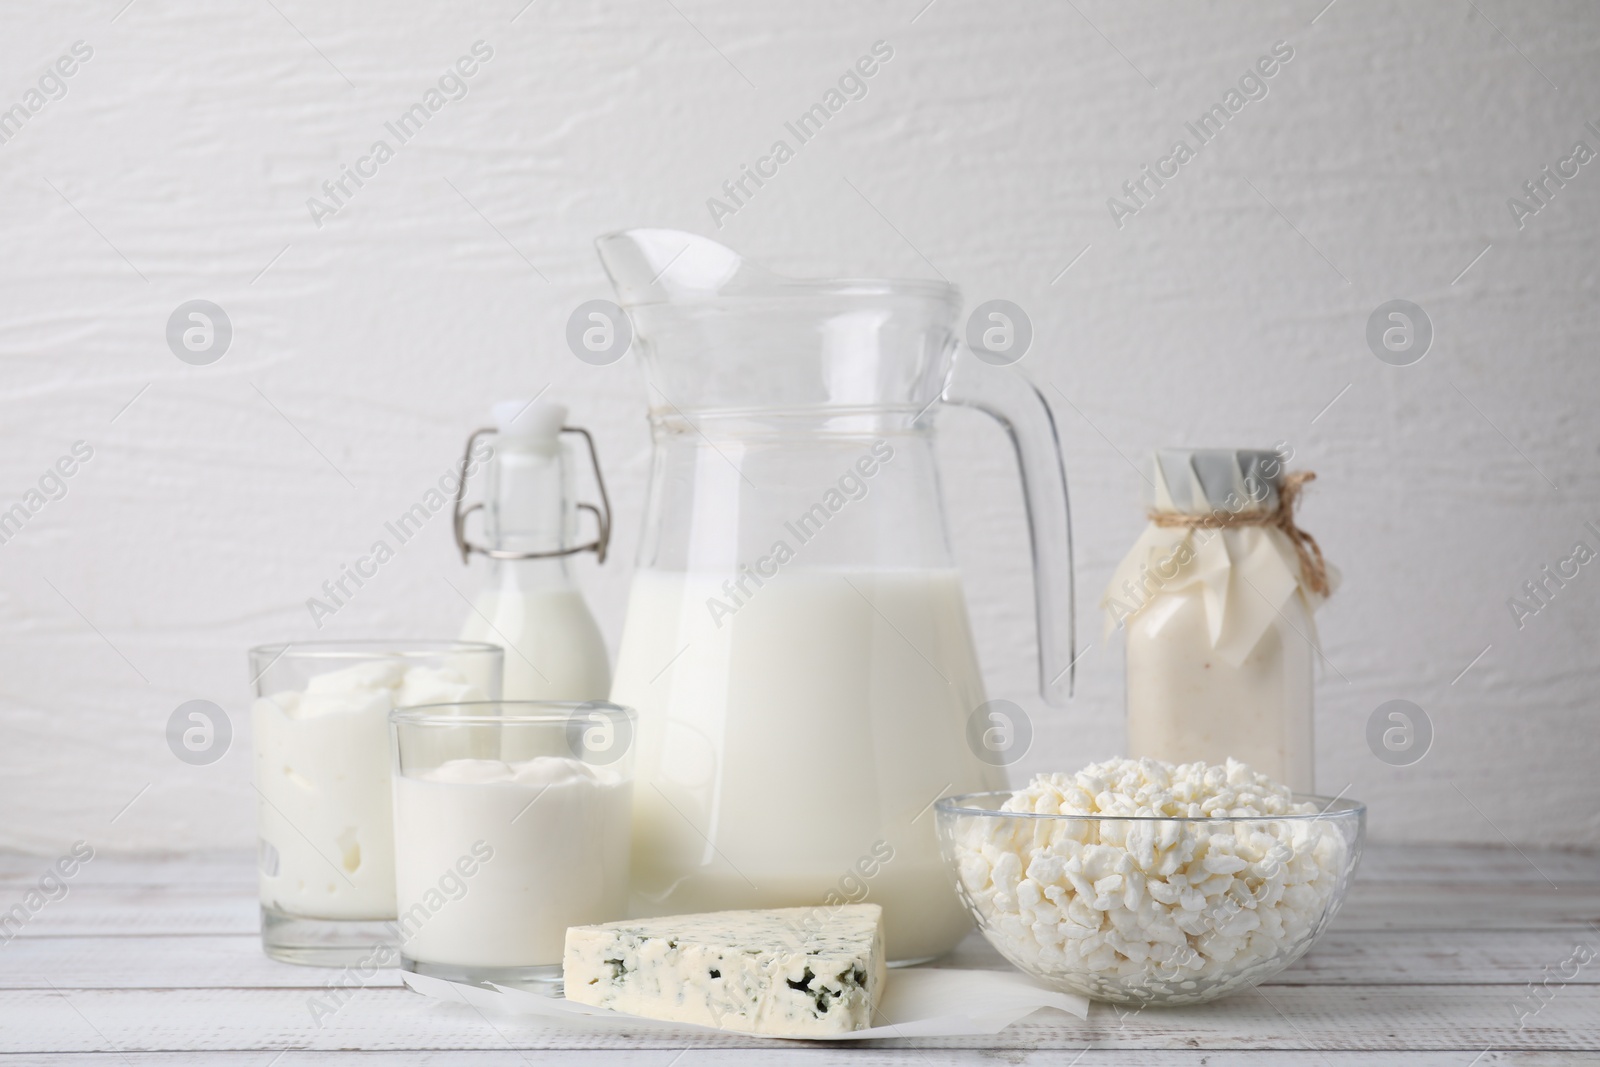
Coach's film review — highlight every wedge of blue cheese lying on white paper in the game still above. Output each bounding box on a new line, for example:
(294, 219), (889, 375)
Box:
(562, 904), (885, 1037)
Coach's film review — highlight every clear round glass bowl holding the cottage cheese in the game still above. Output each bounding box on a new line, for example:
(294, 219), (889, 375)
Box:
(934, 790), (1366, 1005)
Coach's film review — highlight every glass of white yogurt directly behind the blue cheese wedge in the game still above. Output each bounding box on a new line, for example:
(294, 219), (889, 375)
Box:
(389, 701), (637, 993)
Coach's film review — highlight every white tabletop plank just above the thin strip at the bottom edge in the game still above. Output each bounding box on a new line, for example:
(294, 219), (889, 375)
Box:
(0, 985), (1600, 1059)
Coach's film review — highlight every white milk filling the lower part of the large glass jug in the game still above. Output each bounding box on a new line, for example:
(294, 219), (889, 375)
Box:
(611, 568), (1005, 960)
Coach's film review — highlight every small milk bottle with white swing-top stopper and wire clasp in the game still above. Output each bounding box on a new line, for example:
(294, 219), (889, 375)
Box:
(461, 400), (611, 701)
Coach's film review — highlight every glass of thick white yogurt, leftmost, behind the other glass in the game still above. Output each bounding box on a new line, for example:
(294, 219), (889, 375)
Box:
(250, 640), (504, 966)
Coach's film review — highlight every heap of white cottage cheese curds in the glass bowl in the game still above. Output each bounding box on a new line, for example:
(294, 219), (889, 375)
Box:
(952, 760), (1347, 1001)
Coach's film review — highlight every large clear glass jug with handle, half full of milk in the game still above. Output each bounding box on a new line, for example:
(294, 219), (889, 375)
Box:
(597, 230), (1072, 963)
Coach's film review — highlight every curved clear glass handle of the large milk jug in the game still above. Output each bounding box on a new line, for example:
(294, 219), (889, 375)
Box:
(941, 350), (1077, 707)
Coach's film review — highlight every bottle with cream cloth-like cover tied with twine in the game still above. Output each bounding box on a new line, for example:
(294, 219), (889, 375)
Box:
(1101, 450), (1338, 793)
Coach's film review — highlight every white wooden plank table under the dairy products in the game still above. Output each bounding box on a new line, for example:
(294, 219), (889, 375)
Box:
(0, 848), (1600, 1067)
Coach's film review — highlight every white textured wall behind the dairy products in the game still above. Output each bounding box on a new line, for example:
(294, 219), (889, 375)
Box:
(0, 0), (1600, 851)
